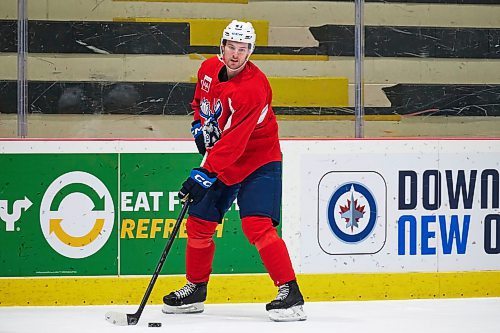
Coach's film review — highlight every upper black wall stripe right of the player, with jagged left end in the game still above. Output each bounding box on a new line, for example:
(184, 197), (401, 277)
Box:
(309, 25), (500, 59)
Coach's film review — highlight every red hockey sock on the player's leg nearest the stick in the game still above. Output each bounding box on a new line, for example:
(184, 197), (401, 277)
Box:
(186, 216), (217, 283)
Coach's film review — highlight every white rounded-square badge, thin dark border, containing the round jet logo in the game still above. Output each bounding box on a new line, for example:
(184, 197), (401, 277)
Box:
(320, 171), (387, 255)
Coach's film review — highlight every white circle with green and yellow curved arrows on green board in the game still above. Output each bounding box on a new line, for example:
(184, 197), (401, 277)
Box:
(40, 171), (115, 258)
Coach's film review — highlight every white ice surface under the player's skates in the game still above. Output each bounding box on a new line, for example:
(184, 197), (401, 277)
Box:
(0, 298), (500, 333)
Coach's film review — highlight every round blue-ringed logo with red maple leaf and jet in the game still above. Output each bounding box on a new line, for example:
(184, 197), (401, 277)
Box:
(328, 182), (377, 243)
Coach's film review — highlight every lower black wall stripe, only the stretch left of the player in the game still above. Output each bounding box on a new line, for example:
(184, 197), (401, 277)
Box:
(0, 81), (195, 115)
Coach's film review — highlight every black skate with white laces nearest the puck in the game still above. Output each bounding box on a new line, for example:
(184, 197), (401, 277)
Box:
(162, 281), (207, 313)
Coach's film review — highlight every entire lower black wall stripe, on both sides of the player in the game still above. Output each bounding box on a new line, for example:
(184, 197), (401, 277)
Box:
(0, 81), (500, 116)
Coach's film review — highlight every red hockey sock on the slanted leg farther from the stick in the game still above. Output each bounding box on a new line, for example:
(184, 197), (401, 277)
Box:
(241, 216), (295, 286)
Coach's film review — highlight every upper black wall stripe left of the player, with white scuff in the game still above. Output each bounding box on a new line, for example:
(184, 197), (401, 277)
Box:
(0, 20), (189, 54)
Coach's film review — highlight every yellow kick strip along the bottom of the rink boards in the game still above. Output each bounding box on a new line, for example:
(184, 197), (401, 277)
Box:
(0, 271), (500, 306)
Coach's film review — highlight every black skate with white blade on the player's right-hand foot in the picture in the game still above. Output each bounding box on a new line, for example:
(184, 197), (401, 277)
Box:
(266, 280), (307, 321)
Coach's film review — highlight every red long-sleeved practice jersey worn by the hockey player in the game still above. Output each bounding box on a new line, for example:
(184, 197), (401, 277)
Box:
(191, 57), (281, 185)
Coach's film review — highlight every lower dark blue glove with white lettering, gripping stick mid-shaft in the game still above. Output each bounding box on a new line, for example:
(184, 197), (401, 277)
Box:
(177, 168), (217, 203)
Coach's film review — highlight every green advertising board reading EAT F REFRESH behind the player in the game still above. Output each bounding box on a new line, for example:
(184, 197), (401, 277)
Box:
(0, 153), (265, 277)
